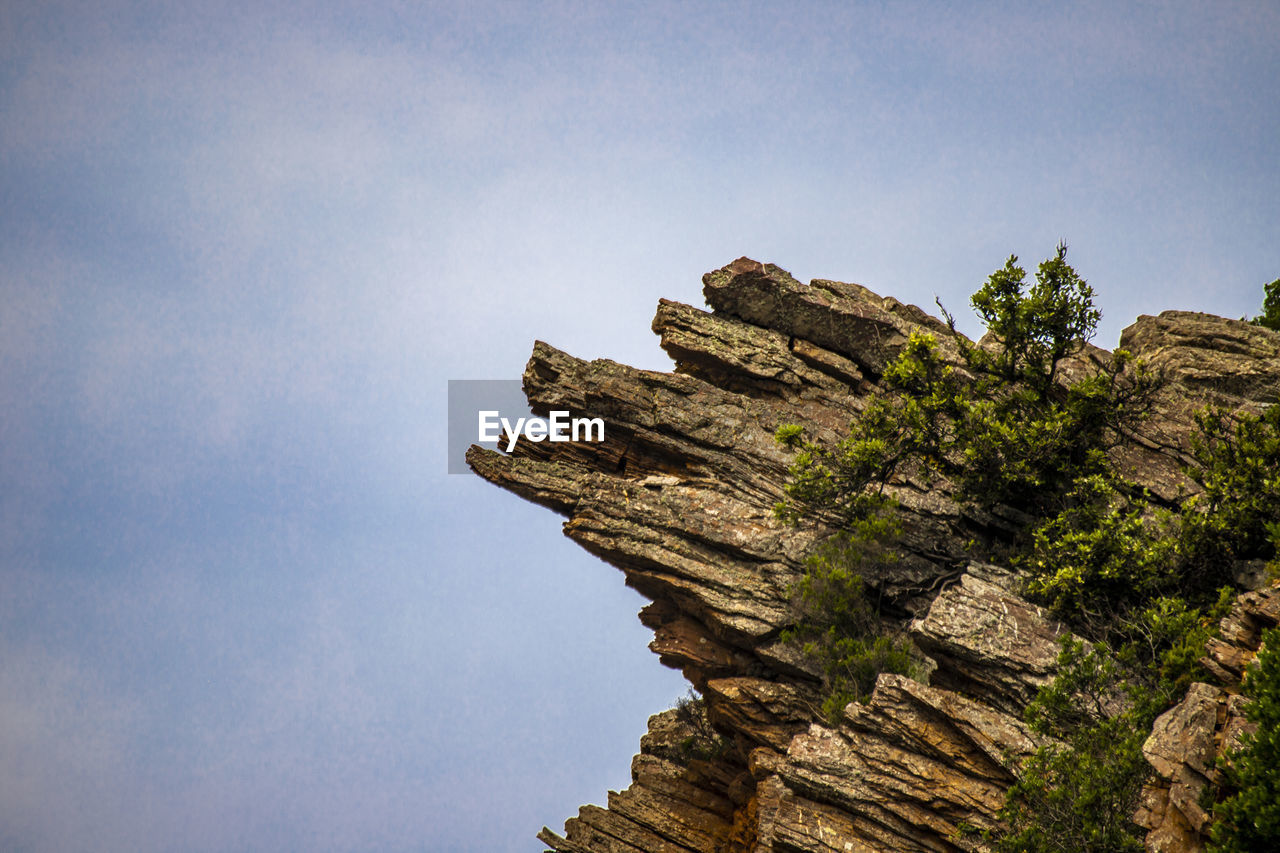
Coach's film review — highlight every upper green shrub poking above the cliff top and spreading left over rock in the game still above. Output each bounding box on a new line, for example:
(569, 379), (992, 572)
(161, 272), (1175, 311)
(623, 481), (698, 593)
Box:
(777, 246), (1157, 521)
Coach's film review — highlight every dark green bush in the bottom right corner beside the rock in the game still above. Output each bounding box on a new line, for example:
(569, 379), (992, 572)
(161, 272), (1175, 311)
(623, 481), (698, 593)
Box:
(1211, 629), (1280, 853)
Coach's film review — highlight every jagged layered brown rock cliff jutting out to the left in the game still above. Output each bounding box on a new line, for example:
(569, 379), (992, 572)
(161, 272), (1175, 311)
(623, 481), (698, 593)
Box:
(467, 259), (1280, 853)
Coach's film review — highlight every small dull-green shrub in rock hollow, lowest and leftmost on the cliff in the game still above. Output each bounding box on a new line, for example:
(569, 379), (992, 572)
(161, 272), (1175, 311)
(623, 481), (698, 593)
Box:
(783, 515), (920, 722)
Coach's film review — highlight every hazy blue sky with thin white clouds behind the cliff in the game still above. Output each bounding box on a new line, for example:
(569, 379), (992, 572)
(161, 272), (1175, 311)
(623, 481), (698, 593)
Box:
(0, 0), (1280, 853)
